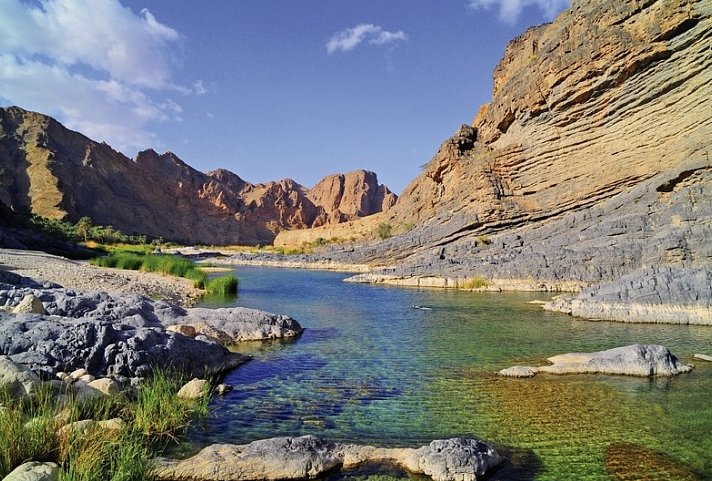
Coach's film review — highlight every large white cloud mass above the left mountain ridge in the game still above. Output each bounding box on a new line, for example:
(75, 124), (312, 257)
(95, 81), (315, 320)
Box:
(0, 0), (193, 151)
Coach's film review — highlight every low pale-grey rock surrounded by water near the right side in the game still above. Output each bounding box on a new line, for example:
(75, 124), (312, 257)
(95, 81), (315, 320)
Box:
(499, 344), (692, 377)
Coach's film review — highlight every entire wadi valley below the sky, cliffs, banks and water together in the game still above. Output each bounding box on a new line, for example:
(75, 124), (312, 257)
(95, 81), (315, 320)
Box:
(0, 0), (712, 481)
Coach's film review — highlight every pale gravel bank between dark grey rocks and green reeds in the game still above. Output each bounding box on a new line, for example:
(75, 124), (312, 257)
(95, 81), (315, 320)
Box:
(0, 249), (202, 307)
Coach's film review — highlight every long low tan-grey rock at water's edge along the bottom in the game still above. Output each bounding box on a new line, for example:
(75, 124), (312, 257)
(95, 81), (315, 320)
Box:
(154, 436), (503, 481)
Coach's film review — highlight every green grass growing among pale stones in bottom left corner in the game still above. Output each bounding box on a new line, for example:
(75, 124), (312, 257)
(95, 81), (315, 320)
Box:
(0, 371), (209, 481)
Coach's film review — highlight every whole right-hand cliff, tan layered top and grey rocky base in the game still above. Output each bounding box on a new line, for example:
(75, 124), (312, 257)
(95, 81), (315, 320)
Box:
(312, 0), (712, 323)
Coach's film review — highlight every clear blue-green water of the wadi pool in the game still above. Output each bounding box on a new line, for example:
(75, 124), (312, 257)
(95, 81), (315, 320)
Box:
(191, 267), (712, 481)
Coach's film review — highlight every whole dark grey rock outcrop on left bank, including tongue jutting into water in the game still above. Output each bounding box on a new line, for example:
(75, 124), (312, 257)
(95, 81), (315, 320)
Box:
(0, 287), (302, 376)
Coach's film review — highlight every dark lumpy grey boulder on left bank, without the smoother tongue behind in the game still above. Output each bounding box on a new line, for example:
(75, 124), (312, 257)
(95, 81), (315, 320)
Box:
(0, 312), (248, 377)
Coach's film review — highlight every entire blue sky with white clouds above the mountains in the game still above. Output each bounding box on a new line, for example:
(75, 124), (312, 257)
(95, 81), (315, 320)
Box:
(0, 0), (568, 192)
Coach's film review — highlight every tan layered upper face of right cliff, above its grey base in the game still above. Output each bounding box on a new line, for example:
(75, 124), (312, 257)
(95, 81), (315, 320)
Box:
(392, 0), (712, 236)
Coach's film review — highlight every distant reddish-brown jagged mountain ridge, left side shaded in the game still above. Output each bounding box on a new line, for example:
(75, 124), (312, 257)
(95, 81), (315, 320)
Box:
(0, 107), (395, 244)
